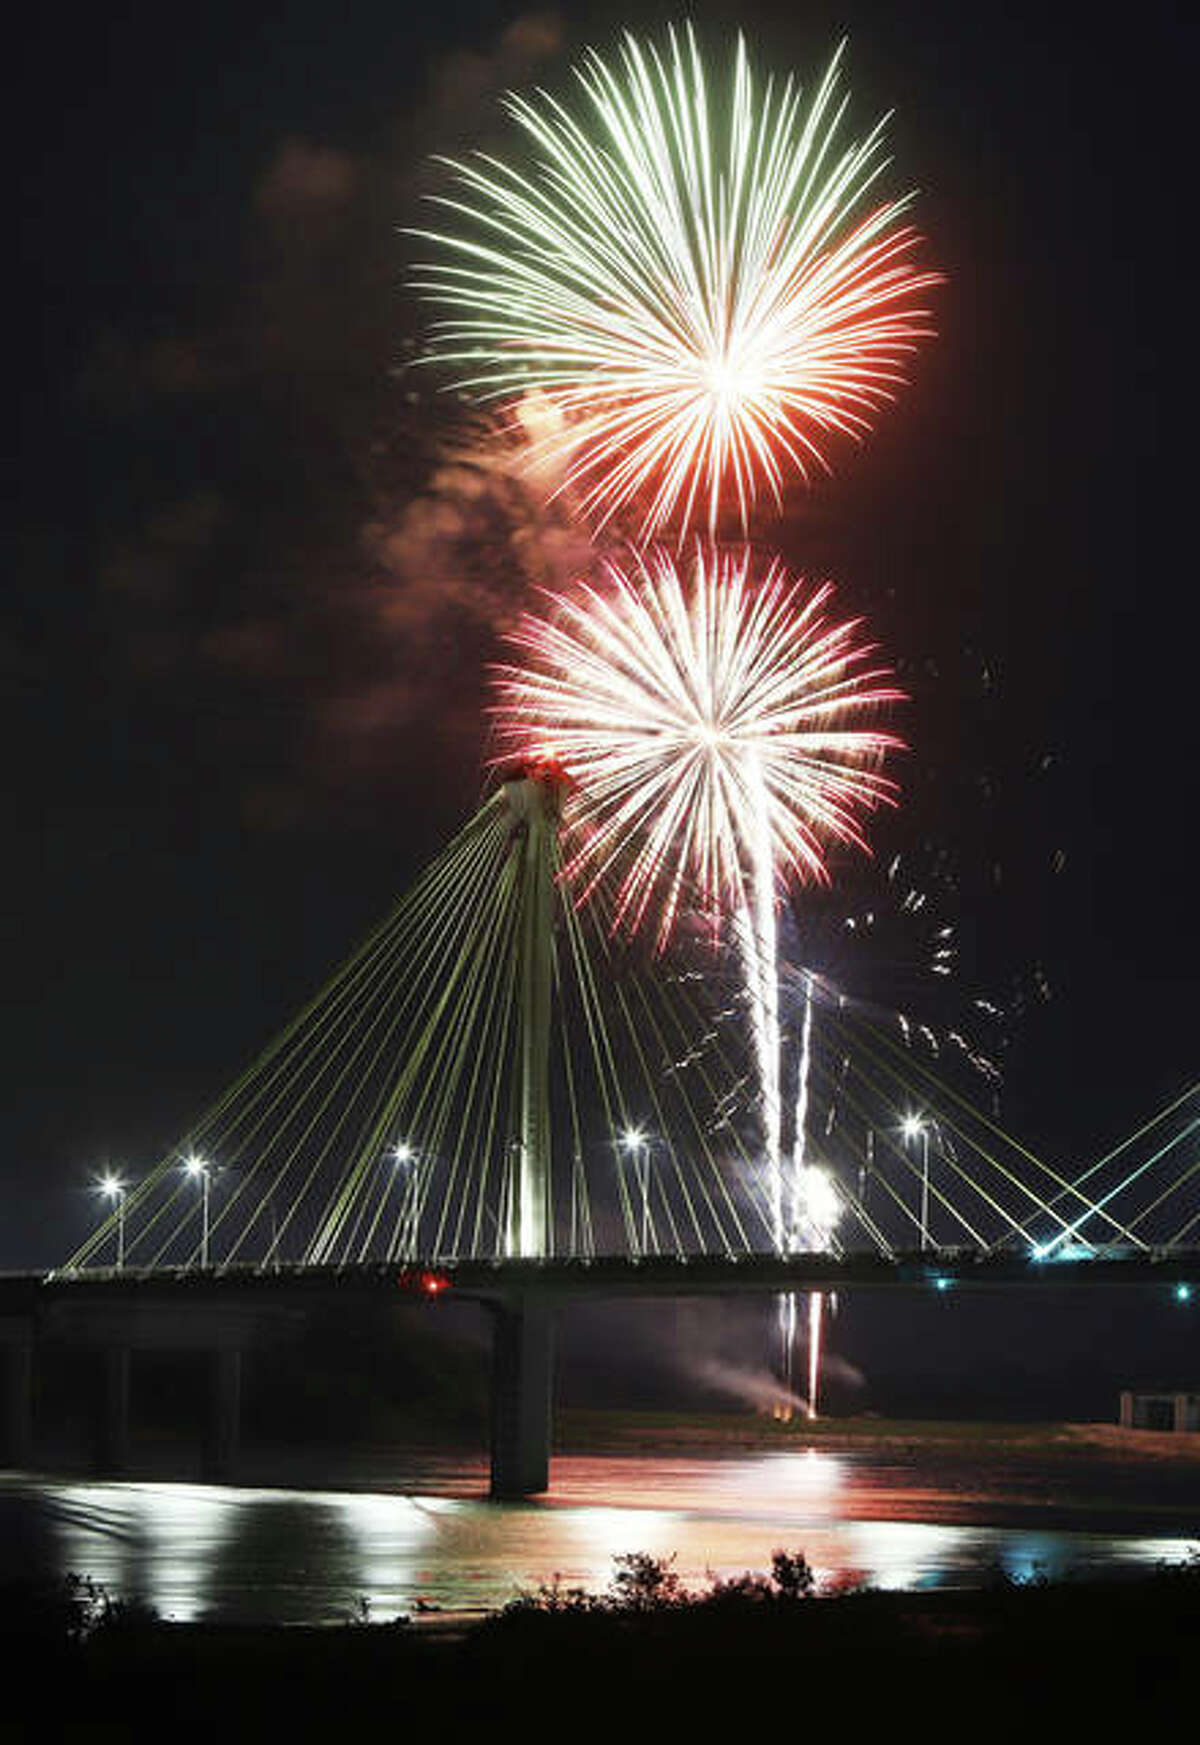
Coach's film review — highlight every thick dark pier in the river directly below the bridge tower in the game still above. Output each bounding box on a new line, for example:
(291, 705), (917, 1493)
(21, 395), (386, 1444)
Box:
(492, 1297), (555, 1499)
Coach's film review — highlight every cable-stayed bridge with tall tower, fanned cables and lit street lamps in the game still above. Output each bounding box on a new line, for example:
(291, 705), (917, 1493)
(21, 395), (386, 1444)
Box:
(0, 770), (1200, 1494)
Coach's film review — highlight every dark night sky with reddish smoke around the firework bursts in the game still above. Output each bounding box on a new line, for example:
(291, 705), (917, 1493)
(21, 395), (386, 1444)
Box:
(0, 0), (1200, 1402)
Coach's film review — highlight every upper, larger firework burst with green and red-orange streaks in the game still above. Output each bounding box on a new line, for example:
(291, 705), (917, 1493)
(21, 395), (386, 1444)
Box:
(417, 30), (938, 539)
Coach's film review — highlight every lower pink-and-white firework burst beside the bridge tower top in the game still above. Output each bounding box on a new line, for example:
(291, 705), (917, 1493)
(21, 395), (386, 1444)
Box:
(494, 546), (902, 949)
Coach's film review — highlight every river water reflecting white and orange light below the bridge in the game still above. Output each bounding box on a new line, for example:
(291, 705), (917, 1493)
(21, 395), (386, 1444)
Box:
(0, 1450), (1200, 1623)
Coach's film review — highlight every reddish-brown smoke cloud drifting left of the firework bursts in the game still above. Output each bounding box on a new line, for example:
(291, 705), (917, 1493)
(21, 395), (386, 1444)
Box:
(77, 10), (590, 831)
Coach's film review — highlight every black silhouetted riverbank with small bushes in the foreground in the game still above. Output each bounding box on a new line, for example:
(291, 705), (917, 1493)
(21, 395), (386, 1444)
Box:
(0, 1551), (1200, 1742)
